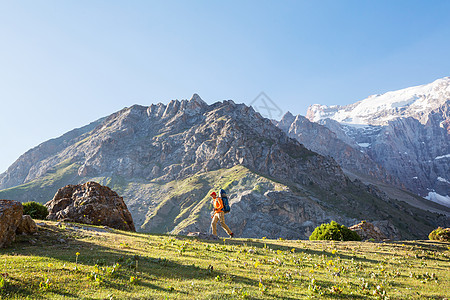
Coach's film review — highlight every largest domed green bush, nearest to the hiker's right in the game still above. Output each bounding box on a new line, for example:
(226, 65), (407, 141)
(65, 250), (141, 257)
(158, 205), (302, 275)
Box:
(309, 221), (361, 241)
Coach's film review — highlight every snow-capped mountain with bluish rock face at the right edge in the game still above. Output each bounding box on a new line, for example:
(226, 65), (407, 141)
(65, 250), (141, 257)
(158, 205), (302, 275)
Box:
(306, 77), (450, 207)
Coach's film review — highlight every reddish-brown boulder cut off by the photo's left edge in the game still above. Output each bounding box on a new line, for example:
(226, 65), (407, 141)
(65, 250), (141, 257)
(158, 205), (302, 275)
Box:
(0, 200), (23, 248)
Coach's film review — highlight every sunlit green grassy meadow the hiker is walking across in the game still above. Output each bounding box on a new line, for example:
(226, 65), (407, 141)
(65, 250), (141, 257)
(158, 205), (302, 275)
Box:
(0, 222), (450, 299)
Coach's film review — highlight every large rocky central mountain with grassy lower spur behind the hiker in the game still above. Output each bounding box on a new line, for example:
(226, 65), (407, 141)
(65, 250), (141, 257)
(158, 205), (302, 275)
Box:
(0, 95), (447, 238)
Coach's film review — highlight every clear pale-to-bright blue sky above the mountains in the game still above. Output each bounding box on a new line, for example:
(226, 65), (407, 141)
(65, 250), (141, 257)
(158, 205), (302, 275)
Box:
(0, 0), (450, 172)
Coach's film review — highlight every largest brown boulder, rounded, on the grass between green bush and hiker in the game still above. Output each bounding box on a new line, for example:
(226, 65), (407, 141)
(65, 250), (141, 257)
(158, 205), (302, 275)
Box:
(45, 181), (136, 231)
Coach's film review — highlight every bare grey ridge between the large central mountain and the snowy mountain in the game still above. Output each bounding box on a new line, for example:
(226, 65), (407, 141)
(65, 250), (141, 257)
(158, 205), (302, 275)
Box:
(273, 112), (450, 215)
